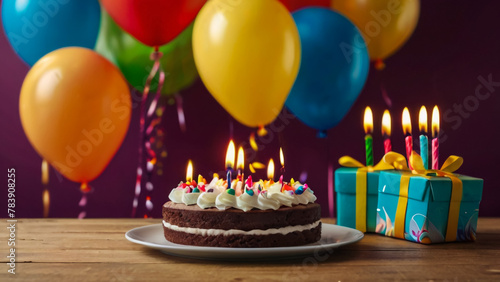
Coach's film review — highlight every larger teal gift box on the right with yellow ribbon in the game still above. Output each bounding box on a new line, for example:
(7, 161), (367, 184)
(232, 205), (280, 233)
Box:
(376, 155), (483, 244)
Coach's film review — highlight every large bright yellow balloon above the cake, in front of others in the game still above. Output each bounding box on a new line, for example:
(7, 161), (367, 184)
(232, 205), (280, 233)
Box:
(193, 0), (300, 127)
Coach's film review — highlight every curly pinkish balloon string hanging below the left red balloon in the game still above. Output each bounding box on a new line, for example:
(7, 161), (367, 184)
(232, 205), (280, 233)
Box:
(131, 47), (165, 217)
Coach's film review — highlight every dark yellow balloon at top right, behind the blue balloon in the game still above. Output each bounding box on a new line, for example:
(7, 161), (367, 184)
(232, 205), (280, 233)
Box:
(332, 0), (420, 60)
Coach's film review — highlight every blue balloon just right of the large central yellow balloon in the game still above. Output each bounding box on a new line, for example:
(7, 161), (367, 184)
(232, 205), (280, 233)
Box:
(285, 8), (370, 136)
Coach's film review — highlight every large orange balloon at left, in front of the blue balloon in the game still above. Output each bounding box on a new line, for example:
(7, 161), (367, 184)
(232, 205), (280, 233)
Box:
(19, 47), (131, 183)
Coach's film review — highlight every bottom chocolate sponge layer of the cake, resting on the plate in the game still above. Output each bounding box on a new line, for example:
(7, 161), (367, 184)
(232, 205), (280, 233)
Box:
(163, 223), (321, 248)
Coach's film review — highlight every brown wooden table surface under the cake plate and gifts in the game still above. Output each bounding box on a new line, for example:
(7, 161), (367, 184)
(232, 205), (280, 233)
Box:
(0, 218), (500, 281)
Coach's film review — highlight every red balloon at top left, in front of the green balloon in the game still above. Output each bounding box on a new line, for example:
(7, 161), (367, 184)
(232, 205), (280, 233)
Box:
(101, 0), (206, 47)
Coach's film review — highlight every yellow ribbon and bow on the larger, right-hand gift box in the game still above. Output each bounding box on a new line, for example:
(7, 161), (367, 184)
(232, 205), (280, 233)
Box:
(382, 151), (464, 242)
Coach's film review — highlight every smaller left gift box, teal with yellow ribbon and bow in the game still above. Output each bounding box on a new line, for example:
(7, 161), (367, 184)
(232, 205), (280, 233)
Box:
(335, 156), (393, 232)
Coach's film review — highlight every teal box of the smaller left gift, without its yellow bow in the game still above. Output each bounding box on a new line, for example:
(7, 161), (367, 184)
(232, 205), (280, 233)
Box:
(335, 167), (380, 232)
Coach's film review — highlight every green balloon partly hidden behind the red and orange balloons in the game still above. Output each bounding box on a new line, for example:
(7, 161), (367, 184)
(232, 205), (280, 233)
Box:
(95, 10), (198, 95)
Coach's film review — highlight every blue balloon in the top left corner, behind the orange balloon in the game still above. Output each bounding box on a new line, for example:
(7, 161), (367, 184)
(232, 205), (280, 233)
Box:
(2, 0), (101, 66)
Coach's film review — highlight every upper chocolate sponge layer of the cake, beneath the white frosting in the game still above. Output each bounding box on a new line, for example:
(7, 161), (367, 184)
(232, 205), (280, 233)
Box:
(162, 202), (321, 231)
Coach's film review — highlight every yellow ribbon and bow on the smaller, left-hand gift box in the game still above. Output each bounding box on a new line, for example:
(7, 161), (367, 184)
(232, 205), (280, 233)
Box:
(339, 156), (394, 232)
